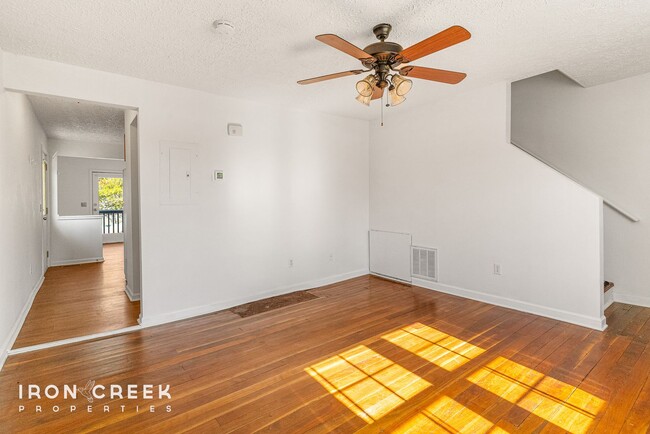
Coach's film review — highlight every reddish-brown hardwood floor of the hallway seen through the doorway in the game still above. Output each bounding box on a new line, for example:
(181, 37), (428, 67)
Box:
(13, 243), (140, 348)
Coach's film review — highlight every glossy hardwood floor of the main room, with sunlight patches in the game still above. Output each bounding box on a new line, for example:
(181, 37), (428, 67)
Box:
(0, 276), (650, 433)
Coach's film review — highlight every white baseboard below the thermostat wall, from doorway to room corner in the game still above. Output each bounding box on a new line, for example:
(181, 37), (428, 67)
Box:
(140, 269), (369, 327)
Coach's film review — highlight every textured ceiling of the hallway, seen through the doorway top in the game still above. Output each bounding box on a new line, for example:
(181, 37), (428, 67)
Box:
(28, 95), (124, 144)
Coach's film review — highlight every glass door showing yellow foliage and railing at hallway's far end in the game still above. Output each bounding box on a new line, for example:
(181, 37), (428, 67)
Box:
(92, 172), (124, 244)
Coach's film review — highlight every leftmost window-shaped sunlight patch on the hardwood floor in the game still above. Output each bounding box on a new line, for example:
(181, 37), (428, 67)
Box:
(305, 345), (431, 423)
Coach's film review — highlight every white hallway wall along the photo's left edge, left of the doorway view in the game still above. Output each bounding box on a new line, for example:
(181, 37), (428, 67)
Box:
(0, 51), (47, 366)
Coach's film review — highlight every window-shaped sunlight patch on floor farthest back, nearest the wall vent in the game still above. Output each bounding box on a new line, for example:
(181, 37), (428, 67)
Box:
(382, 323), (484, 371)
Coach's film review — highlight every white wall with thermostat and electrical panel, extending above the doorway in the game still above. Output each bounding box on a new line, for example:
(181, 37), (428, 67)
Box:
(4, 53), (368, 323)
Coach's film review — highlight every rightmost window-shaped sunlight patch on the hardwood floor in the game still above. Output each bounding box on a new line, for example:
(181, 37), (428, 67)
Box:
(467, 357), (604, 433)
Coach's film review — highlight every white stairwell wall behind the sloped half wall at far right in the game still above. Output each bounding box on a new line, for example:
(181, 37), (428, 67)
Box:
(512, 71), (650, 306)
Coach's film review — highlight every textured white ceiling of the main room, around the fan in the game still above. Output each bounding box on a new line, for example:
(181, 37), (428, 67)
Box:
(0, 0), (650, 118)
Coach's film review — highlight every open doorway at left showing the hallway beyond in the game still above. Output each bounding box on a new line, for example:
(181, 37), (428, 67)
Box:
(8, 95), (140, 349)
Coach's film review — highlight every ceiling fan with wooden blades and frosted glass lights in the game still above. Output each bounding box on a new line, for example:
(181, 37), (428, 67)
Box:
(298, 23), (471, 106)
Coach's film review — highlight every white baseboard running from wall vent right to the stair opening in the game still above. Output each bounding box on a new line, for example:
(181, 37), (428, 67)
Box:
(413, 278), (607, 331)
